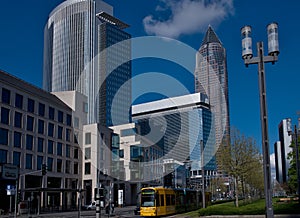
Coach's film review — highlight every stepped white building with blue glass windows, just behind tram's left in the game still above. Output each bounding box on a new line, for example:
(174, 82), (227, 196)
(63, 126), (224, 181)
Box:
(110, 123), (162, 205)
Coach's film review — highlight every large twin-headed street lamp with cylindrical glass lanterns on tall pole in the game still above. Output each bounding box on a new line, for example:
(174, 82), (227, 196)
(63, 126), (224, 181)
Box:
(241, 23), (279, 217)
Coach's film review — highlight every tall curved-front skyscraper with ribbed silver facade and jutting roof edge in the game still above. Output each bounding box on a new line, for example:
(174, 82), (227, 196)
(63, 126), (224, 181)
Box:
(43, 0), (131, 126)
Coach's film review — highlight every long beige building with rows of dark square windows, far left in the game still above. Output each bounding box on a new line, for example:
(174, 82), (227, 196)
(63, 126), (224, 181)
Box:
(0, 71), (86, 209)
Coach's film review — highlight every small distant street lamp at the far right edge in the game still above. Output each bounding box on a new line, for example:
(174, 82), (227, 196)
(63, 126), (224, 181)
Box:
(287, 118), (300, 203)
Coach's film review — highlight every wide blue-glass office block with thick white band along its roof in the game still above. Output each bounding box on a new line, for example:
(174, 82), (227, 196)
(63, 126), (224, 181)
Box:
(132, 93), (216, 187)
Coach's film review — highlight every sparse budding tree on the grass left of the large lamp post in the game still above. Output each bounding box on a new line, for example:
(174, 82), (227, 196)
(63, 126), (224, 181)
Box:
(217, 129), (264, 207)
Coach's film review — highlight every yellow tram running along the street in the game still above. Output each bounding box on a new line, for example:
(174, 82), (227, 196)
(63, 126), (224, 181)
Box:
(140, 187), (206, 217)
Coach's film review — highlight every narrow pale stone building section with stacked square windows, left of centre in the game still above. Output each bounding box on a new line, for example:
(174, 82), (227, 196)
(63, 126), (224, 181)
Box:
(82, 123), (113, 204)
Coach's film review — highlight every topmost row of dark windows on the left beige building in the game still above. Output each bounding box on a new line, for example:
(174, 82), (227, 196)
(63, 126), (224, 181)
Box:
(1, 88), (72, 126)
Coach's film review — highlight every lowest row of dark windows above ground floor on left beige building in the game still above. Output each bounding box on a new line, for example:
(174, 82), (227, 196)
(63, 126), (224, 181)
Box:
(0, 149), (79, 174)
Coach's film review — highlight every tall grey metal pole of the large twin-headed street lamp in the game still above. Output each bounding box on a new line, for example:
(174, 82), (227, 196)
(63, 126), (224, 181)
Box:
(257, 42), (274, 218)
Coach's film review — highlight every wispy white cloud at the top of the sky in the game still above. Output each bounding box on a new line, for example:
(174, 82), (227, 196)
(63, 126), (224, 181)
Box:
(143, 0), (234, 38)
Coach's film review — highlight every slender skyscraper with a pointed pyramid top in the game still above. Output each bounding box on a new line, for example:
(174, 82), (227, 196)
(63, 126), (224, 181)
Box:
(195, 26), (230, 148)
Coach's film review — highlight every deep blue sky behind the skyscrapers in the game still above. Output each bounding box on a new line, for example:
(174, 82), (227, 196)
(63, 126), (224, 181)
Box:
(0, 0), (300, 158)
